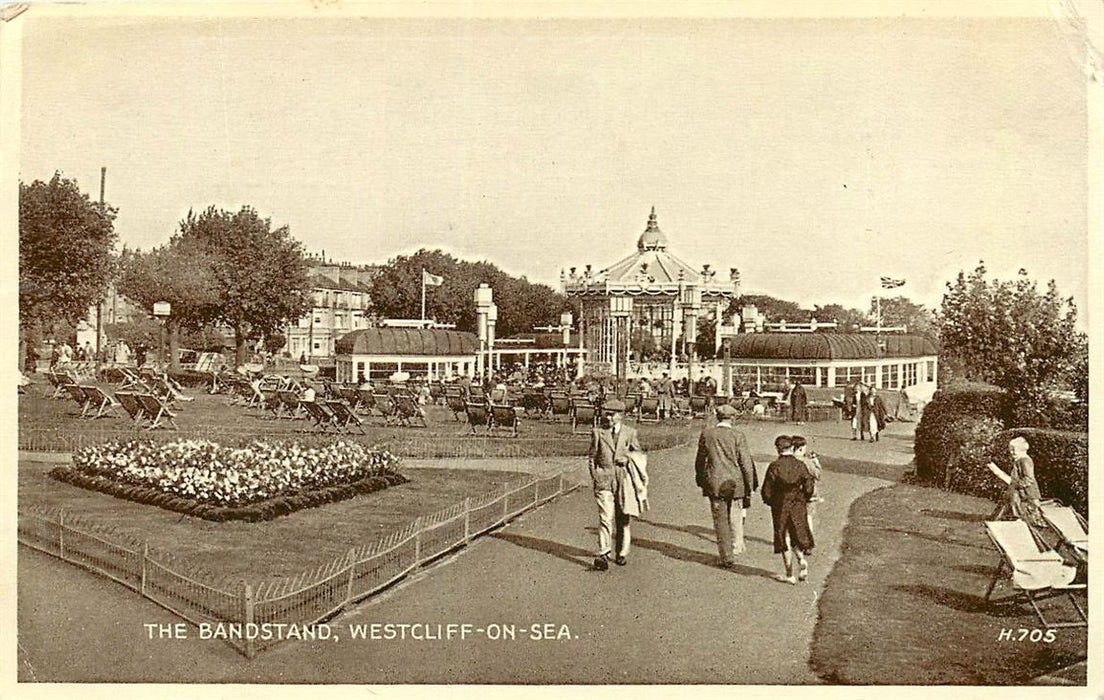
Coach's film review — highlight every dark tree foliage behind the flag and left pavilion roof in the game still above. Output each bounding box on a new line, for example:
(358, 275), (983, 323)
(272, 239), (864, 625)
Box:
(371, 248), (570, 337)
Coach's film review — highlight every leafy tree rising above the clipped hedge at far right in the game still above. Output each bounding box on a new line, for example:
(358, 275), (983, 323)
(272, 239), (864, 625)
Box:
(938, 263), (1084, 426)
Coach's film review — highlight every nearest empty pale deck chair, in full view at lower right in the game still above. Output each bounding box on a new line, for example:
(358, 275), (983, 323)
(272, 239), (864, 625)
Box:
(985, 520), (1089, 629)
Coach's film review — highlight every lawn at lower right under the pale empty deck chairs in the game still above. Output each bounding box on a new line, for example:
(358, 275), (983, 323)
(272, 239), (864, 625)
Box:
(811, 484), (1087, 686)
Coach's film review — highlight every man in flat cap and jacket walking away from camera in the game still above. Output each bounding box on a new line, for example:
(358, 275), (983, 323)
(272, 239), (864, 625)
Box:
(694, 404), (758, 568)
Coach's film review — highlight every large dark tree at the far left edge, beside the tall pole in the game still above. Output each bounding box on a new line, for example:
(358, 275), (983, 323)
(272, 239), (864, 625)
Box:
(19, 172), (116, 358)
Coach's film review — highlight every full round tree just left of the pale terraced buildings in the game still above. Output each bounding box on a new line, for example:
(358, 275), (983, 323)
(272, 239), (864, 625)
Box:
(179, 206), (310, 363)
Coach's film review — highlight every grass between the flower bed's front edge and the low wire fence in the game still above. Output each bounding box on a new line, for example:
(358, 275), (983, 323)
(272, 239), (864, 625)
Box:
(19, 454), (522, 582)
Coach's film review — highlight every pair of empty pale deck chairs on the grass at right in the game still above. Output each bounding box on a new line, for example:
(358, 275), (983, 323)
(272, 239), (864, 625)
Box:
(985, 501), (1089, 629)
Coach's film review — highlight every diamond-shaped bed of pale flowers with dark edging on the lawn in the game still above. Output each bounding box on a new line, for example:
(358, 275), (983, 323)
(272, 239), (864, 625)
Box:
(50, 439), (407, 521)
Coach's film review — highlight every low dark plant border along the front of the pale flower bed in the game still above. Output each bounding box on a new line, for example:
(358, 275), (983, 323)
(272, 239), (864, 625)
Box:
(50, 466), (410, 522)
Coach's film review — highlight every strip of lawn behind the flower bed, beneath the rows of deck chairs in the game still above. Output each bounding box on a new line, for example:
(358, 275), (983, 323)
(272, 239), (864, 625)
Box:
(19, 380), (692, 458)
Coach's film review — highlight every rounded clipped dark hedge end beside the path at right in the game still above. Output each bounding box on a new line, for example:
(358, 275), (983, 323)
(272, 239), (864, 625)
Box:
(914, 382), (1007, 487)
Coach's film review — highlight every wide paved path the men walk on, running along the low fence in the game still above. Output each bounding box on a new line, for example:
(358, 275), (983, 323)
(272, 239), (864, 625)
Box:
(19, 423), (912, 683)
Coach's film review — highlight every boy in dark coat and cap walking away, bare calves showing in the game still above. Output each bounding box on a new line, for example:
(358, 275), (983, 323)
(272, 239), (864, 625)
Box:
(761, 435), (816, 584)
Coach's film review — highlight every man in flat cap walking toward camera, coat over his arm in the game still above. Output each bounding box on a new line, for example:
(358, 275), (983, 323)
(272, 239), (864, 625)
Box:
(590, 399), (647, 571)
